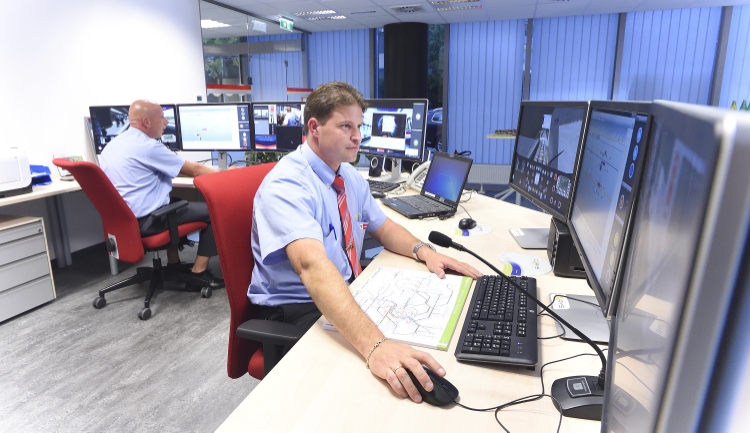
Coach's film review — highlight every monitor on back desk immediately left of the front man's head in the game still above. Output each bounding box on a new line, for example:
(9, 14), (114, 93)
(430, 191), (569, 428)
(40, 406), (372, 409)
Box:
(251, 102), (306, 152)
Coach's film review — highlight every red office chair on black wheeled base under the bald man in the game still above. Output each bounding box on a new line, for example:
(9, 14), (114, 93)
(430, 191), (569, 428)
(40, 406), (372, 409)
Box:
(52, 158), (216, 320)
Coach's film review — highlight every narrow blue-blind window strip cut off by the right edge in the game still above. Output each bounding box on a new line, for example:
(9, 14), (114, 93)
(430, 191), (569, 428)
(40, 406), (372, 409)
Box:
(719, 6), (750, 108)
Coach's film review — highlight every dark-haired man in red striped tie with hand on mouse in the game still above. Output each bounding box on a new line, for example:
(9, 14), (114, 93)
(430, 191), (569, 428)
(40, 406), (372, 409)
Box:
(248, 82), (480, 402)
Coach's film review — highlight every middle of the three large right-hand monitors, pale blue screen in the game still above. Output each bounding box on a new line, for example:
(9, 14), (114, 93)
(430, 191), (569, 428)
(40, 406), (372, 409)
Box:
(568, 101), (650, 315)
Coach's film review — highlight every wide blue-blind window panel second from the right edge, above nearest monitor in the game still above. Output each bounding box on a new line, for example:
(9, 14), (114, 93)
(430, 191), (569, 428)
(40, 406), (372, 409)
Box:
(614, 7), (721, 104)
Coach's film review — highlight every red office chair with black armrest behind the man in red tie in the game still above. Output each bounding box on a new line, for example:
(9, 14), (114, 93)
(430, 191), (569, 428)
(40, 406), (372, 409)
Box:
(195, 163), (305, 379)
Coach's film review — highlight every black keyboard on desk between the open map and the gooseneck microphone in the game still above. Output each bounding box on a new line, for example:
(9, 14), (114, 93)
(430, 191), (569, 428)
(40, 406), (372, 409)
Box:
(456, 275), (538, 366)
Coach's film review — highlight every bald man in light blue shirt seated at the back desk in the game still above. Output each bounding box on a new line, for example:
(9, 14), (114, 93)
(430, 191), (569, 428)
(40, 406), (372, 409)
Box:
(99, 100), (224, 288)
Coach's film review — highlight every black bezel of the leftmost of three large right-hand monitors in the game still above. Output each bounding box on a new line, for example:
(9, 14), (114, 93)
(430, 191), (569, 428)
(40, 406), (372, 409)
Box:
(508, 101), (591, 223)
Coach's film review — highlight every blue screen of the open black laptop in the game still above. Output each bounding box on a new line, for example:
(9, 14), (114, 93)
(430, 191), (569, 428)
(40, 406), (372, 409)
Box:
(422, 153), (472, 203)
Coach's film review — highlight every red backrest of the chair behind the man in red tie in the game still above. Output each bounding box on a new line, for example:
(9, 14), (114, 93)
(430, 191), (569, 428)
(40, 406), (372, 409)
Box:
(195, 163), (276, 379)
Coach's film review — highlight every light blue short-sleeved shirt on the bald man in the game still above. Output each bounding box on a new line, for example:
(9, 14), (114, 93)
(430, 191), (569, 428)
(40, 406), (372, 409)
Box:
(99, 128), (185, 218)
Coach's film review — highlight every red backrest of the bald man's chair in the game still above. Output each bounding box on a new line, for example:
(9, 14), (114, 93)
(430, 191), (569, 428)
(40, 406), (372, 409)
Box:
(52, 158), (145, 263)
